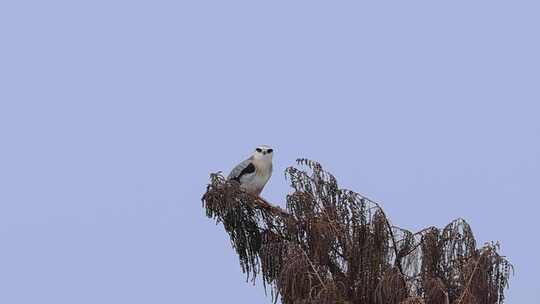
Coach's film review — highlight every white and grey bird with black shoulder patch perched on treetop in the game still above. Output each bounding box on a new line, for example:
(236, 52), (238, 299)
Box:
(227, 145), (274, 195)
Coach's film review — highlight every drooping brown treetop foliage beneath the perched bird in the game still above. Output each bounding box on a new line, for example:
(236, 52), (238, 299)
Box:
(202, 159), (512, 304)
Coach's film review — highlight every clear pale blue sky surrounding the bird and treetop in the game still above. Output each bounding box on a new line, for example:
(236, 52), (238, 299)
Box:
(0, 0), (540, 304)
